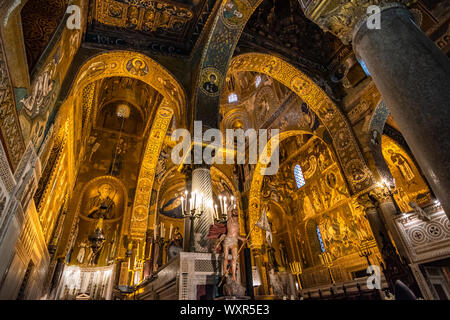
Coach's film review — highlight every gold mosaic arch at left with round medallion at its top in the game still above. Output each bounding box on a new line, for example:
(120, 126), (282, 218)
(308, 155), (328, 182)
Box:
(60, 51), (186, 241)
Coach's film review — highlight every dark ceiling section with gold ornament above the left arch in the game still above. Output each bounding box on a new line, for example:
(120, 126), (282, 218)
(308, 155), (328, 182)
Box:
(86, 0), (215, 55)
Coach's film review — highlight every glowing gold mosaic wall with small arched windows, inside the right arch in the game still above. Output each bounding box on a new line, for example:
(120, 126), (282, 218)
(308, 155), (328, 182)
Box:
(262, 136), (378, 286)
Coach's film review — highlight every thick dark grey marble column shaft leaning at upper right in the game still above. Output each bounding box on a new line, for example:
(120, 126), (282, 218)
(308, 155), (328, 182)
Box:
(353, 5), (450, 217)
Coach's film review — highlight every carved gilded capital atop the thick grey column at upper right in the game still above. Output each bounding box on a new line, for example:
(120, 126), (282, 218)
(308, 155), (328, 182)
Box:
(300, 0), (417, 44)
